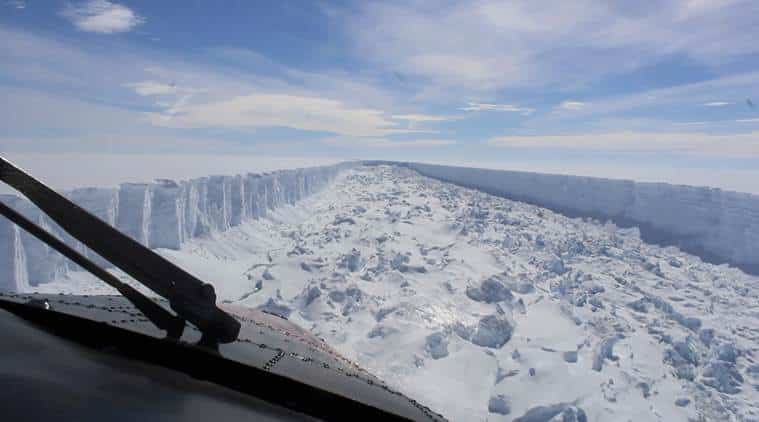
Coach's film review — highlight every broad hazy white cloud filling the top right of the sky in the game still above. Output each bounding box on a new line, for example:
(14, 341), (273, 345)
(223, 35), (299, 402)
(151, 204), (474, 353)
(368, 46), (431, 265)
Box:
(346, 0), (759, 92)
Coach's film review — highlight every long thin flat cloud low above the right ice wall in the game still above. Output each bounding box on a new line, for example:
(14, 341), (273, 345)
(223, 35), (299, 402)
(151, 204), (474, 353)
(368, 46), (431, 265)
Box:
(486, 132), (759, 157)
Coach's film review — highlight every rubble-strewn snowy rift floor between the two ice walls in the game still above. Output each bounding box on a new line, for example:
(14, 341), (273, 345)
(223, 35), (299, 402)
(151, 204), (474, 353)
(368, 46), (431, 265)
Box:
(22, 166), (759, 422)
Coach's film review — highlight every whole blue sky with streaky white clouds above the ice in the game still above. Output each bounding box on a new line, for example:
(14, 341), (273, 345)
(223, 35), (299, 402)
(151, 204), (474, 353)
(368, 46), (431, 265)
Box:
(0, 0), (759, 193)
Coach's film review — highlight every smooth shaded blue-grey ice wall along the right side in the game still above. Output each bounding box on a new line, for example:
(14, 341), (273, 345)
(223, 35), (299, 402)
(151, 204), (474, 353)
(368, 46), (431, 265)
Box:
(394, 163), (759, 274)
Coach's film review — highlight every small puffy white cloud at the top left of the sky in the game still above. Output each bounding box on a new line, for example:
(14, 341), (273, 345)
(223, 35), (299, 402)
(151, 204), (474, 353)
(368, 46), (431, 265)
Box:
(61, 0), (145, 34)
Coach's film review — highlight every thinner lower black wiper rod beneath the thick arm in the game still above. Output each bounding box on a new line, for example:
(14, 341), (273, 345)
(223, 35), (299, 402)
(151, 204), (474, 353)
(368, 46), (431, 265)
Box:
(0, 202), (185, 340)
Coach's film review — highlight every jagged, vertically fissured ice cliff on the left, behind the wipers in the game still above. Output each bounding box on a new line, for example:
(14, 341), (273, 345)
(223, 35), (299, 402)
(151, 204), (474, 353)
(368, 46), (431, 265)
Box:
(0, 162), (355, 291)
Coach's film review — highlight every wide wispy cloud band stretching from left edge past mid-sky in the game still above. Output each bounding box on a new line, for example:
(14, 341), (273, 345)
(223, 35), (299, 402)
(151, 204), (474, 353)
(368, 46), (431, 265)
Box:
(0, 26), (428, 151)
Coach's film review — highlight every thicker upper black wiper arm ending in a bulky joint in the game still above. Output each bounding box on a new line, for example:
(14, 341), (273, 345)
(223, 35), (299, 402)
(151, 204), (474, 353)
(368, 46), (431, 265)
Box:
(0, 157), (240, 345)
